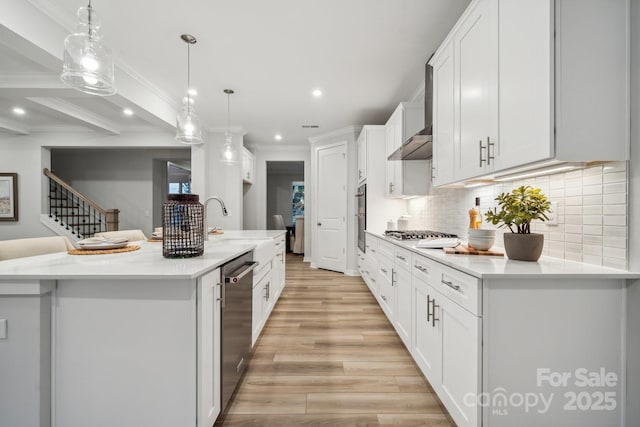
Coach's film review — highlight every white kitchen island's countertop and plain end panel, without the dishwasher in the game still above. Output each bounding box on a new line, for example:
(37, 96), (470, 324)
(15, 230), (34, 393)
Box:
(0, 231), (284, 427)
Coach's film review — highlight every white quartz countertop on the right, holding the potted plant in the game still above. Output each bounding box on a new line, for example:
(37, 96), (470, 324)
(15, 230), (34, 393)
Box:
(370, 233), (640, 279)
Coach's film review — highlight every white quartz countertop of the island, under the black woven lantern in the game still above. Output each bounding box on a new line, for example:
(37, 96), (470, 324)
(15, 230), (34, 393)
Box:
(0, 230), (284, 281)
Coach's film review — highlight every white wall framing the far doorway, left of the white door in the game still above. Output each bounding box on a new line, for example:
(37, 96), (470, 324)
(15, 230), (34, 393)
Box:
(244, 145), (311, 261)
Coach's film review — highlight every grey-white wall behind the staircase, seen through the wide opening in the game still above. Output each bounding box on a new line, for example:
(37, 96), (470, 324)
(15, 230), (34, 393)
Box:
(51, 147), (191, 236)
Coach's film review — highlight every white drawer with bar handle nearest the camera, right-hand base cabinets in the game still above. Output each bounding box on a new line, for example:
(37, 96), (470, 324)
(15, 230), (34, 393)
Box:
(433, 265), (482, 316)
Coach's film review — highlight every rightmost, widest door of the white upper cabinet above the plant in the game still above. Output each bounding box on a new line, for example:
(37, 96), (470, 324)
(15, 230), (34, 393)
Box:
(494, 0), (554, 170)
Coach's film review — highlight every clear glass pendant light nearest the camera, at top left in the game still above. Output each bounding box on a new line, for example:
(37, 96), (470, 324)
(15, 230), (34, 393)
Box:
(60, 0), (116, 96)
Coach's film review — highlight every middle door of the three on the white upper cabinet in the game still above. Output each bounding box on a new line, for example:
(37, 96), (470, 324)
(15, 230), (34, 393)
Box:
(454, 0), (498, 180)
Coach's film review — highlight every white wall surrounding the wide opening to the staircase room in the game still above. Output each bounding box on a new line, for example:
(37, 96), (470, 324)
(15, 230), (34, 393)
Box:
(0, 131), (242, 240)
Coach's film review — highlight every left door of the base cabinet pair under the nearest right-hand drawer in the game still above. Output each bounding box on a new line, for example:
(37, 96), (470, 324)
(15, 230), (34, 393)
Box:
(411, 276), (442, 386)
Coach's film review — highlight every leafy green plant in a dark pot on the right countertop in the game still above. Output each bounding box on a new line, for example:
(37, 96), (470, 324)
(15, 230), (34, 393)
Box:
(485, 185), (551, 261)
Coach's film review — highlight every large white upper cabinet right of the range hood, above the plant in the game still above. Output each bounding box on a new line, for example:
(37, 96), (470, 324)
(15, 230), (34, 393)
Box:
(430, 0), (629, 185)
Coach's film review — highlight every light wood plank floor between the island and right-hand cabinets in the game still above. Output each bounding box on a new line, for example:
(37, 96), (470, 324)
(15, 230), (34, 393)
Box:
(216, 254), (455, 427)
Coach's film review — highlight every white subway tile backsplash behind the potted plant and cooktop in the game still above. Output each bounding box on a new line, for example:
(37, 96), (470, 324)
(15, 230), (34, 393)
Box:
(407, 162), (628, 268)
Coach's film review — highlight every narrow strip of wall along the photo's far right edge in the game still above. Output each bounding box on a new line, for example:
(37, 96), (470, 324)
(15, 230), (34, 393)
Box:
(627, 0), (640, 426)
